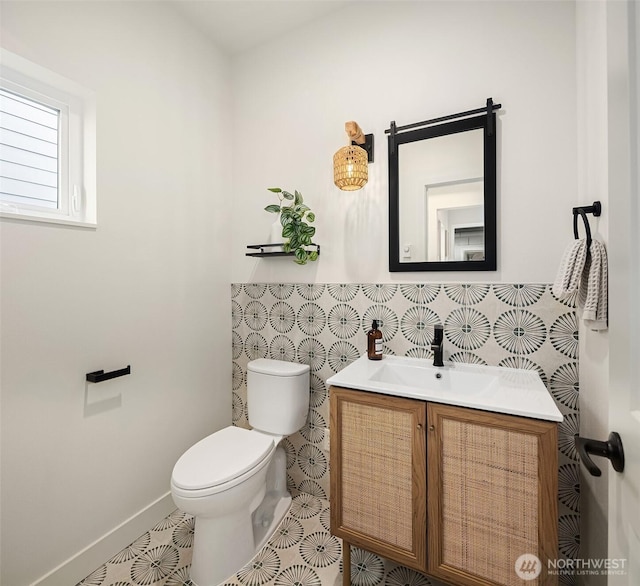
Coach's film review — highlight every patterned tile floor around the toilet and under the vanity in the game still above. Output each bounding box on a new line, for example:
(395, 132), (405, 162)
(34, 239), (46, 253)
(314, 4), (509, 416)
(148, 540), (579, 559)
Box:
(76, 493), (432, 586)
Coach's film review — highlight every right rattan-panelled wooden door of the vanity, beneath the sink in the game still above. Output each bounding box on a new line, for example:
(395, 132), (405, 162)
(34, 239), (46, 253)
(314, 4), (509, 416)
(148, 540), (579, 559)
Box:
(427, 403), (558, 586)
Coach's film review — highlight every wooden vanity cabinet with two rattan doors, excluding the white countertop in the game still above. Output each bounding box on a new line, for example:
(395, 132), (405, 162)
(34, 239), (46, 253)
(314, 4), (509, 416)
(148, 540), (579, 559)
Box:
(330, 387), (558, 586)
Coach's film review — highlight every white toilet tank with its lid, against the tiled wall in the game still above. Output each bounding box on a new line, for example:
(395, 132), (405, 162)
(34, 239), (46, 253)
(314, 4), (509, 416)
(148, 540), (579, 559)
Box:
(247, 358), (309, 435)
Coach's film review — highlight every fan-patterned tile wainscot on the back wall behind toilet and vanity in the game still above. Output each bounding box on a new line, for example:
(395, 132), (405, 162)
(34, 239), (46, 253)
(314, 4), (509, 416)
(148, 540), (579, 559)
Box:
(231, 283), (580, 576)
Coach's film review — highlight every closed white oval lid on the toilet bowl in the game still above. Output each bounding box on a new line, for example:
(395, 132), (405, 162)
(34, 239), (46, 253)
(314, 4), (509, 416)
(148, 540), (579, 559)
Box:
(172, 426), (274, 490)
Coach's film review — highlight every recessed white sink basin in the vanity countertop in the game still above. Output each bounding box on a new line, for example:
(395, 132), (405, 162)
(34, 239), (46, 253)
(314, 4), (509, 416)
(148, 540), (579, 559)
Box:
(369, 360), (498, 394)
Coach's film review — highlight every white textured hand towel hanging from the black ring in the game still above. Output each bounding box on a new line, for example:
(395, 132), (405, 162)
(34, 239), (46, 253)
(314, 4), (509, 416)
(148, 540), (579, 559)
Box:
(552, 239), (609, 330)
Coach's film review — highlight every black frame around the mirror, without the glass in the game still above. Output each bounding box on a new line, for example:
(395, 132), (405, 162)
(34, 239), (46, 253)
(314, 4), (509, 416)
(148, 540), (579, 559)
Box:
(388, 112), (497, 273)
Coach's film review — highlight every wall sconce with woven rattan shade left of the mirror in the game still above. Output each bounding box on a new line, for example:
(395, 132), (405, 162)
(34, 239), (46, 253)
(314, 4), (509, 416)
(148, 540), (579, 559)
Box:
(333, 121), (373, 191)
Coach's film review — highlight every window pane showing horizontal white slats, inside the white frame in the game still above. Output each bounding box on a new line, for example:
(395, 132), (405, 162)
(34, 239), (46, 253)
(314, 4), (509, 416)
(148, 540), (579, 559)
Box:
(0, 89), (60, 209)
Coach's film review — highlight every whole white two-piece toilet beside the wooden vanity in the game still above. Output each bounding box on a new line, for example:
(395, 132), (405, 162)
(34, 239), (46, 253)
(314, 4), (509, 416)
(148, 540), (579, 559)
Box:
(171, 358), (309, 586)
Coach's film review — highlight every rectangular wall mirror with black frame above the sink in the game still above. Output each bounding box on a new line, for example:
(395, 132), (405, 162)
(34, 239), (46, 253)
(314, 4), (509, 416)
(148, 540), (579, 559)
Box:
(389, 106), (499, 272)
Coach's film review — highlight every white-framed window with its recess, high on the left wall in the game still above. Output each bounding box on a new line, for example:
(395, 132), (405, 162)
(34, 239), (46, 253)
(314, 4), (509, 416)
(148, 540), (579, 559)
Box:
(0, 50), (96, 226)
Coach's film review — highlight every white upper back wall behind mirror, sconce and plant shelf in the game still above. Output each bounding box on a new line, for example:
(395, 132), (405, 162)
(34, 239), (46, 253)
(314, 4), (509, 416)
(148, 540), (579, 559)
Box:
(232, 1), (577, 282)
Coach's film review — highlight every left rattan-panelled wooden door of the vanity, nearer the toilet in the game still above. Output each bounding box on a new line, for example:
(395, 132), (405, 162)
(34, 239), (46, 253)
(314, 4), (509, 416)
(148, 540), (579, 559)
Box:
(329, 387), (427, 571)
